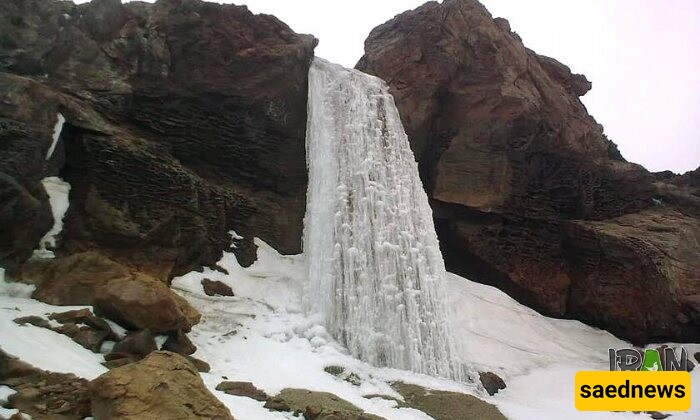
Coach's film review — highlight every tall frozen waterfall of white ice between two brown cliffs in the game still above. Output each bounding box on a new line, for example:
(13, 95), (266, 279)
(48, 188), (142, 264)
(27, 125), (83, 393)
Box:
(304, 58), (461, 379)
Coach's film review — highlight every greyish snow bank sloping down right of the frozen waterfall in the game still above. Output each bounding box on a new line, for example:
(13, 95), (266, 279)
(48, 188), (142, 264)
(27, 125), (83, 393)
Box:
(448, 274), (628, 376)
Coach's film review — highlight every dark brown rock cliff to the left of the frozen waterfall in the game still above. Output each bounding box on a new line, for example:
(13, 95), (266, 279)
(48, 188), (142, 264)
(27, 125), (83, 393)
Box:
(0, 0), (316, 280)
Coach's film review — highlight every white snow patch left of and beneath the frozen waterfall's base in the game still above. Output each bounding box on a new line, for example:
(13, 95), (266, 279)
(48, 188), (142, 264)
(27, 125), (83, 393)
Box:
(172, 239), (475, 419)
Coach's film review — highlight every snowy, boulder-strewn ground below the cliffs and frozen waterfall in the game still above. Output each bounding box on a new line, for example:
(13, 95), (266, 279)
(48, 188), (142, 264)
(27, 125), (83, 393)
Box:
(5, 240), (700, 420)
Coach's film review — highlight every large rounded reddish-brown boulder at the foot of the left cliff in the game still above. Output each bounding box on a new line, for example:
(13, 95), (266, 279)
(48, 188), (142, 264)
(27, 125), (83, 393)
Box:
(94, 273), (201, 334)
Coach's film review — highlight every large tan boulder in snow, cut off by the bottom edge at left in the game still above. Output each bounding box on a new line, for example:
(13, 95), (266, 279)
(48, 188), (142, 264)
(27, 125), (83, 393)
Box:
(89, 351), (233, 420)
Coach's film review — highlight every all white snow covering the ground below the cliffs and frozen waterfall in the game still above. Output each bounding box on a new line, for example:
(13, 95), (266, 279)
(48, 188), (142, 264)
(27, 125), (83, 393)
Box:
(0, 240), (700, 420)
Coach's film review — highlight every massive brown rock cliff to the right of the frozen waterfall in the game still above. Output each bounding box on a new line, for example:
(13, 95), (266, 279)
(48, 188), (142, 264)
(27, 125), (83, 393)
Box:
(357, 0), (700, 342)
